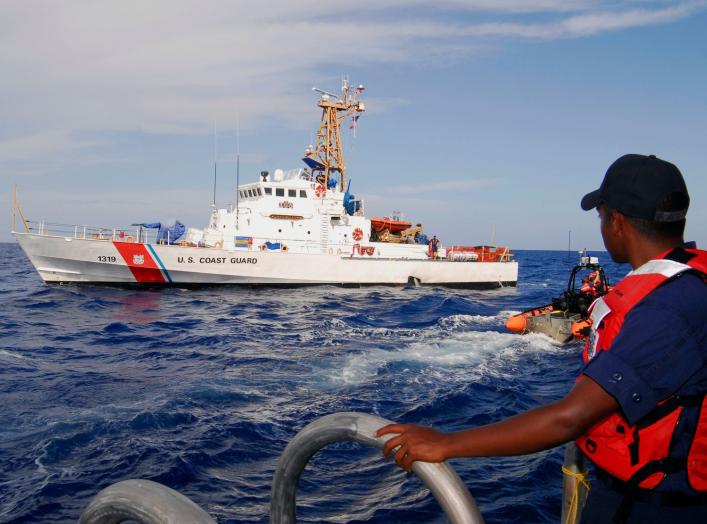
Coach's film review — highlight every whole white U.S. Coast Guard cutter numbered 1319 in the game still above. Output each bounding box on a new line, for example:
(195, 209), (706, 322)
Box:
(13, 81), (518, 288)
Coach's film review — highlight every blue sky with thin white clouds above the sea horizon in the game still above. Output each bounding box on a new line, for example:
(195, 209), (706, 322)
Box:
(0, 0), (707, 250)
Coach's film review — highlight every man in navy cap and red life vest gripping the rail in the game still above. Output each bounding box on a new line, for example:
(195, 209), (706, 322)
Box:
(377, 155), (707, 524)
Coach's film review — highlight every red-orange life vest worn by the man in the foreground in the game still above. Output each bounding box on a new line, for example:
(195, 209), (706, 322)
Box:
(577, 248), (707, 492)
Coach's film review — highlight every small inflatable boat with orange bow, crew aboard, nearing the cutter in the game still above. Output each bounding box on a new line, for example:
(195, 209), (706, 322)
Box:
(506, 253), (611, 344)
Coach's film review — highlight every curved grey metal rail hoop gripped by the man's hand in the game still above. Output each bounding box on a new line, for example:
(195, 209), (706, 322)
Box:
(270, 413), (484, 524)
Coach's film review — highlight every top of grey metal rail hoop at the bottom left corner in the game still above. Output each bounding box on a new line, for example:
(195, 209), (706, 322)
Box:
(79, 479), (216, 524)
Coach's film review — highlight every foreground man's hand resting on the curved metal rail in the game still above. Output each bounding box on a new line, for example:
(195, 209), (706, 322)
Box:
(376, 424), (450, 471)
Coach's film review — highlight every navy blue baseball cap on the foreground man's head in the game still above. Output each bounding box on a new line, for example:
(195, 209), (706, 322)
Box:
(582, 154), (690, 222)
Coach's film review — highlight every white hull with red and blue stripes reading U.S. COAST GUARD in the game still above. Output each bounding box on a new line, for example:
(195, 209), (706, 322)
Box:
(14, 232), (518, 288)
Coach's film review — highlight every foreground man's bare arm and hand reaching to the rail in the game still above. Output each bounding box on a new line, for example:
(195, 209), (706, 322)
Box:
(376, 375), (619, 471)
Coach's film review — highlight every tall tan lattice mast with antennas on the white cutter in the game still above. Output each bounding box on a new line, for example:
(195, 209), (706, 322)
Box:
(302, 79), (366, 192)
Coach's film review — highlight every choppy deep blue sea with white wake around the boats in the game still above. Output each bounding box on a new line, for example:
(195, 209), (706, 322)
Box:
(0, 243), (629, 524)
